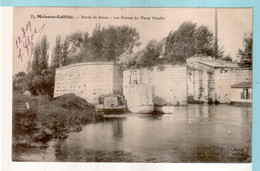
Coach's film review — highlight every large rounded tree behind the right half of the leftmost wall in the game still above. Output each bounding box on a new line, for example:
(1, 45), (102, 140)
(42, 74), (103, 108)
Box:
(83, 25), (140, 61)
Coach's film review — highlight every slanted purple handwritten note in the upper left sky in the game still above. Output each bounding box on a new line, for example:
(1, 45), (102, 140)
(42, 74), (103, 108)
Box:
(15, 21), (45, 69)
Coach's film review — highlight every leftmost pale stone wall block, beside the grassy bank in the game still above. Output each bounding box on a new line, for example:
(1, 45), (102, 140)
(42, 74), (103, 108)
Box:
(54, 62), (123, 103)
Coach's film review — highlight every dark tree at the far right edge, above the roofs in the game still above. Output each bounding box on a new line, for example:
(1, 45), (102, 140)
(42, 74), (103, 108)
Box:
(238, 33), (253, 68)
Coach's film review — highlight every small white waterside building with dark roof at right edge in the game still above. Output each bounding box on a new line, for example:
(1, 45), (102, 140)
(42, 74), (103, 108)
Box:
(231, 82), (252, 105)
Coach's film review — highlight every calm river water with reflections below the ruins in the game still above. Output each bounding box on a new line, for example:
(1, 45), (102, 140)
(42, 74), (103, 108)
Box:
(14, 104), (252, 163)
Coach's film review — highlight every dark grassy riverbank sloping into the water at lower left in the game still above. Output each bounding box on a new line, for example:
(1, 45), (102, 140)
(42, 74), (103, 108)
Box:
(12, 93), (103, 160)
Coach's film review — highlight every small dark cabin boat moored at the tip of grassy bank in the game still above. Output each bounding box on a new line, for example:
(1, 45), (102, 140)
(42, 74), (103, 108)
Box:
(95, 94), (126, 114)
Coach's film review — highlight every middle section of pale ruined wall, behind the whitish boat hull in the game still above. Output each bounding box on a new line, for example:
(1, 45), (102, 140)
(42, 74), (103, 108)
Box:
(123, 65), (187, 105)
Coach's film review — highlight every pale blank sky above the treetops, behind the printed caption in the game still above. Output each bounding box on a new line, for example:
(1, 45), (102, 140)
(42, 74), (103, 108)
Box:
(13, 7), (253, 74)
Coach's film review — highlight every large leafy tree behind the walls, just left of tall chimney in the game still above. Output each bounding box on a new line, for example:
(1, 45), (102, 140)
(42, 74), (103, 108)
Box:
(164, 22), (218, 64)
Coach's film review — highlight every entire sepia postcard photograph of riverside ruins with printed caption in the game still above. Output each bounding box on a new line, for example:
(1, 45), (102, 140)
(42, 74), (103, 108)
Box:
(11, 7), (253, 163)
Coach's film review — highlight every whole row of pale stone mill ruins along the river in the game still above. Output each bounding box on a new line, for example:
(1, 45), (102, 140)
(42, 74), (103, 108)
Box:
(54, 55), (252, 105)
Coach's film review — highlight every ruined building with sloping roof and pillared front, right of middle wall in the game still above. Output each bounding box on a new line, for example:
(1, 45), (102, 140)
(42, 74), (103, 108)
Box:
(187, 56), (252, 103)
